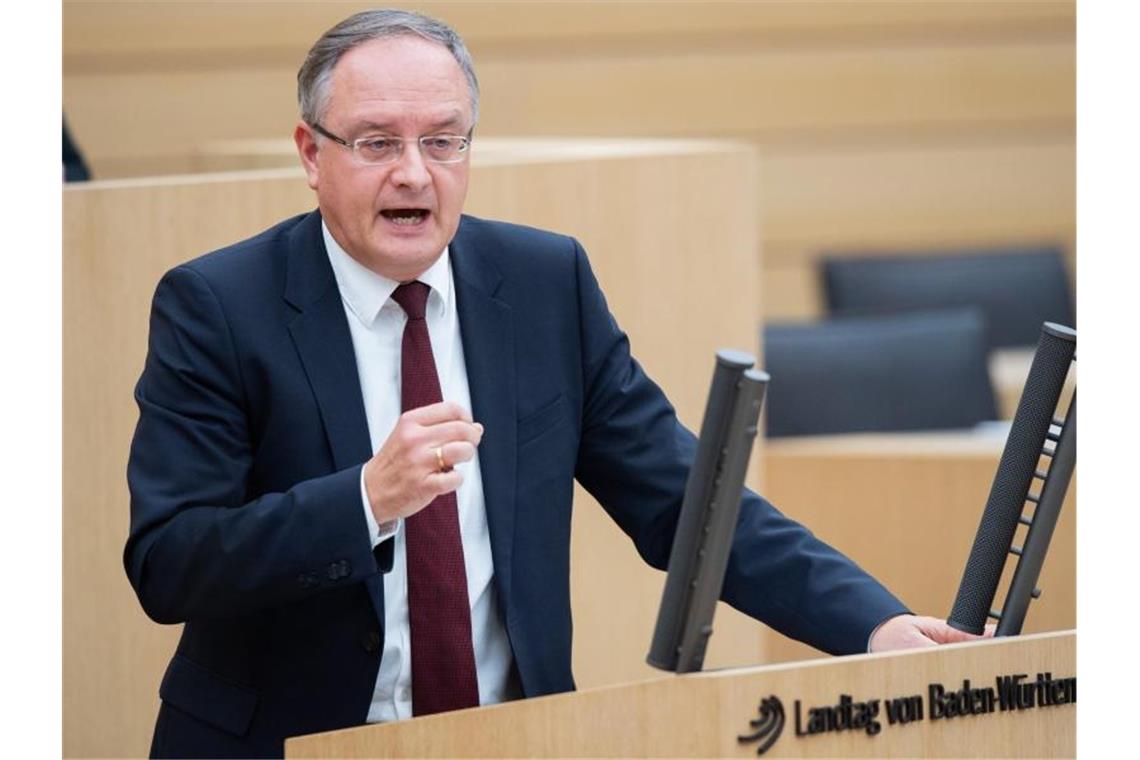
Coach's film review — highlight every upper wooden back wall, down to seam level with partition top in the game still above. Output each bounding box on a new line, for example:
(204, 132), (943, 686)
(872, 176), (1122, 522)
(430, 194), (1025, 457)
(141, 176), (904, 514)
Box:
(64, 2), (1075, 177)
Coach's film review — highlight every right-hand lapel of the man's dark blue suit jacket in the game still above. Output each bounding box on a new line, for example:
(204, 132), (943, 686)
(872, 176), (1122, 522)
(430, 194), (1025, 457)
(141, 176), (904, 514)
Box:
(450, 220), (518, 619)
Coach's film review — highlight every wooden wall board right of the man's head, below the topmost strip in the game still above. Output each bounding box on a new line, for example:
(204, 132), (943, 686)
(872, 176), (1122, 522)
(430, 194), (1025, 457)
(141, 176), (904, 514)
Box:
(469, 42), (1075, 139)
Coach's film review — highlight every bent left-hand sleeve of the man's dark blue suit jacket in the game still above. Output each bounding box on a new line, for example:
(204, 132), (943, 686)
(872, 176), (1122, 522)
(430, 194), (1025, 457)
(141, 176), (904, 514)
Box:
(123, 267), (376, 623)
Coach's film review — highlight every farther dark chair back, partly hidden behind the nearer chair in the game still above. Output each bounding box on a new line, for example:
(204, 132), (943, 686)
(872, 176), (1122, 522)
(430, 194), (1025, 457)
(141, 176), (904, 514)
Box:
(823, 247), (1076, 349)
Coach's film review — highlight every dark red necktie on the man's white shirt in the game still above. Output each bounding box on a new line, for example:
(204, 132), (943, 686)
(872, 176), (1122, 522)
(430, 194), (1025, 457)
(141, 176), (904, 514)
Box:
(392, 280), (479, 716)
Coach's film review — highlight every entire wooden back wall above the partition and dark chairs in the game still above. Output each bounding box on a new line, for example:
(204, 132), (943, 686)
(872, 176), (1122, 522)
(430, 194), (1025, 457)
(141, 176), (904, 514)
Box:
(64, 0), (1075, 319)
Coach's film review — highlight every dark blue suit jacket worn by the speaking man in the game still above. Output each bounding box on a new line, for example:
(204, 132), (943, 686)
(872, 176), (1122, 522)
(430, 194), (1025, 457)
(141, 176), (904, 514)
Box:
(124, 213), (904, 757)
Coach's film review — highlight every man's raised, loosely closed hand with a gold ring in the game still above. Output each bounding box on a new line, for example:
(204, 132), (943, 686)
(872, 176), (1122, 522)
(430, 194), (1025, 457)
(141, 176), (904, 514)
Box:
(364, 401), (483, 525)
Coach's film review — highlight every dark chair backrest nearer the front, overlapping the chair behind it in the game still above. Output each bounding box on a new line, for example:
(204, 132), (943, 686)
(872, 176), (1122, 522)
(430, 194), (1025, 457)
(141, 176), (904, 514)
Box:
(764, 309), (998, 438)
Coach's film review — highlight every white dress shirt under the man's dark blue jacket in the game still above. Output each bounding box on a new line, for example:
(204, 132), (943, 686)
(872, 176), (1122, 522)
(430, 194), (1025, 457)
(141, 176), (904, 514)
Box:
(321, 222), (519, 722)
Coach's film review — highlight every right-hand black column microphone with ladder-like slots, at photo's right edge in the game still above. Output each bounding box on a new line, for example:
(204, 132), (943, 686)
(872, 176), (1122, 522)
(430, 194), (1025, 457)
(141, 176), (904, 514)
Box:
(946, 322), (1076, 636)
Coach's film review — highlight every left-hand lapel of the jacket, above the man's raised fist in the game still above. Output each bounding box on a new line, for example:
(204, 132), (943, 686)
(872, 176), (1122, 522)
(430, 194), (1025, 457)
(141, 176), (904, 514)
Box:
(285, 212), (390, 624)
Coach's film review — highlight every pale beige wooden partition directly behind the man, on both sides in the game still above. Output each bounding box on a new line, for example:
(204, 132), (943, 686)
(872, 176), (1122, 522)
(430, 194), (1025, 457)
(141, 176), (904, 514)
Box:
(64, 145), (763, 757)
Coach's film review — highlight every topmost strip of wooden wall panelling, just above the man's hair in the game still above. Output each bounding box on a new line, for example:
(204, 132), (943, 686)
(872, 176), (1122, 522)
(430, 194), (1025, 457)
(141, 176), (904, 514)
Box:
(63, 0), (1076, 64)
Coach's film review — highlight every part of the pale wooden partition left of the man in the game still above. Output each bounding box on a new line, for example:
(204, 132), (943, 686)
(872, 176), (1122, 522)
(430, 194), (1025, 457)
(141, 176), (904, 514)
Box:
(64, 167), (311, 757)
